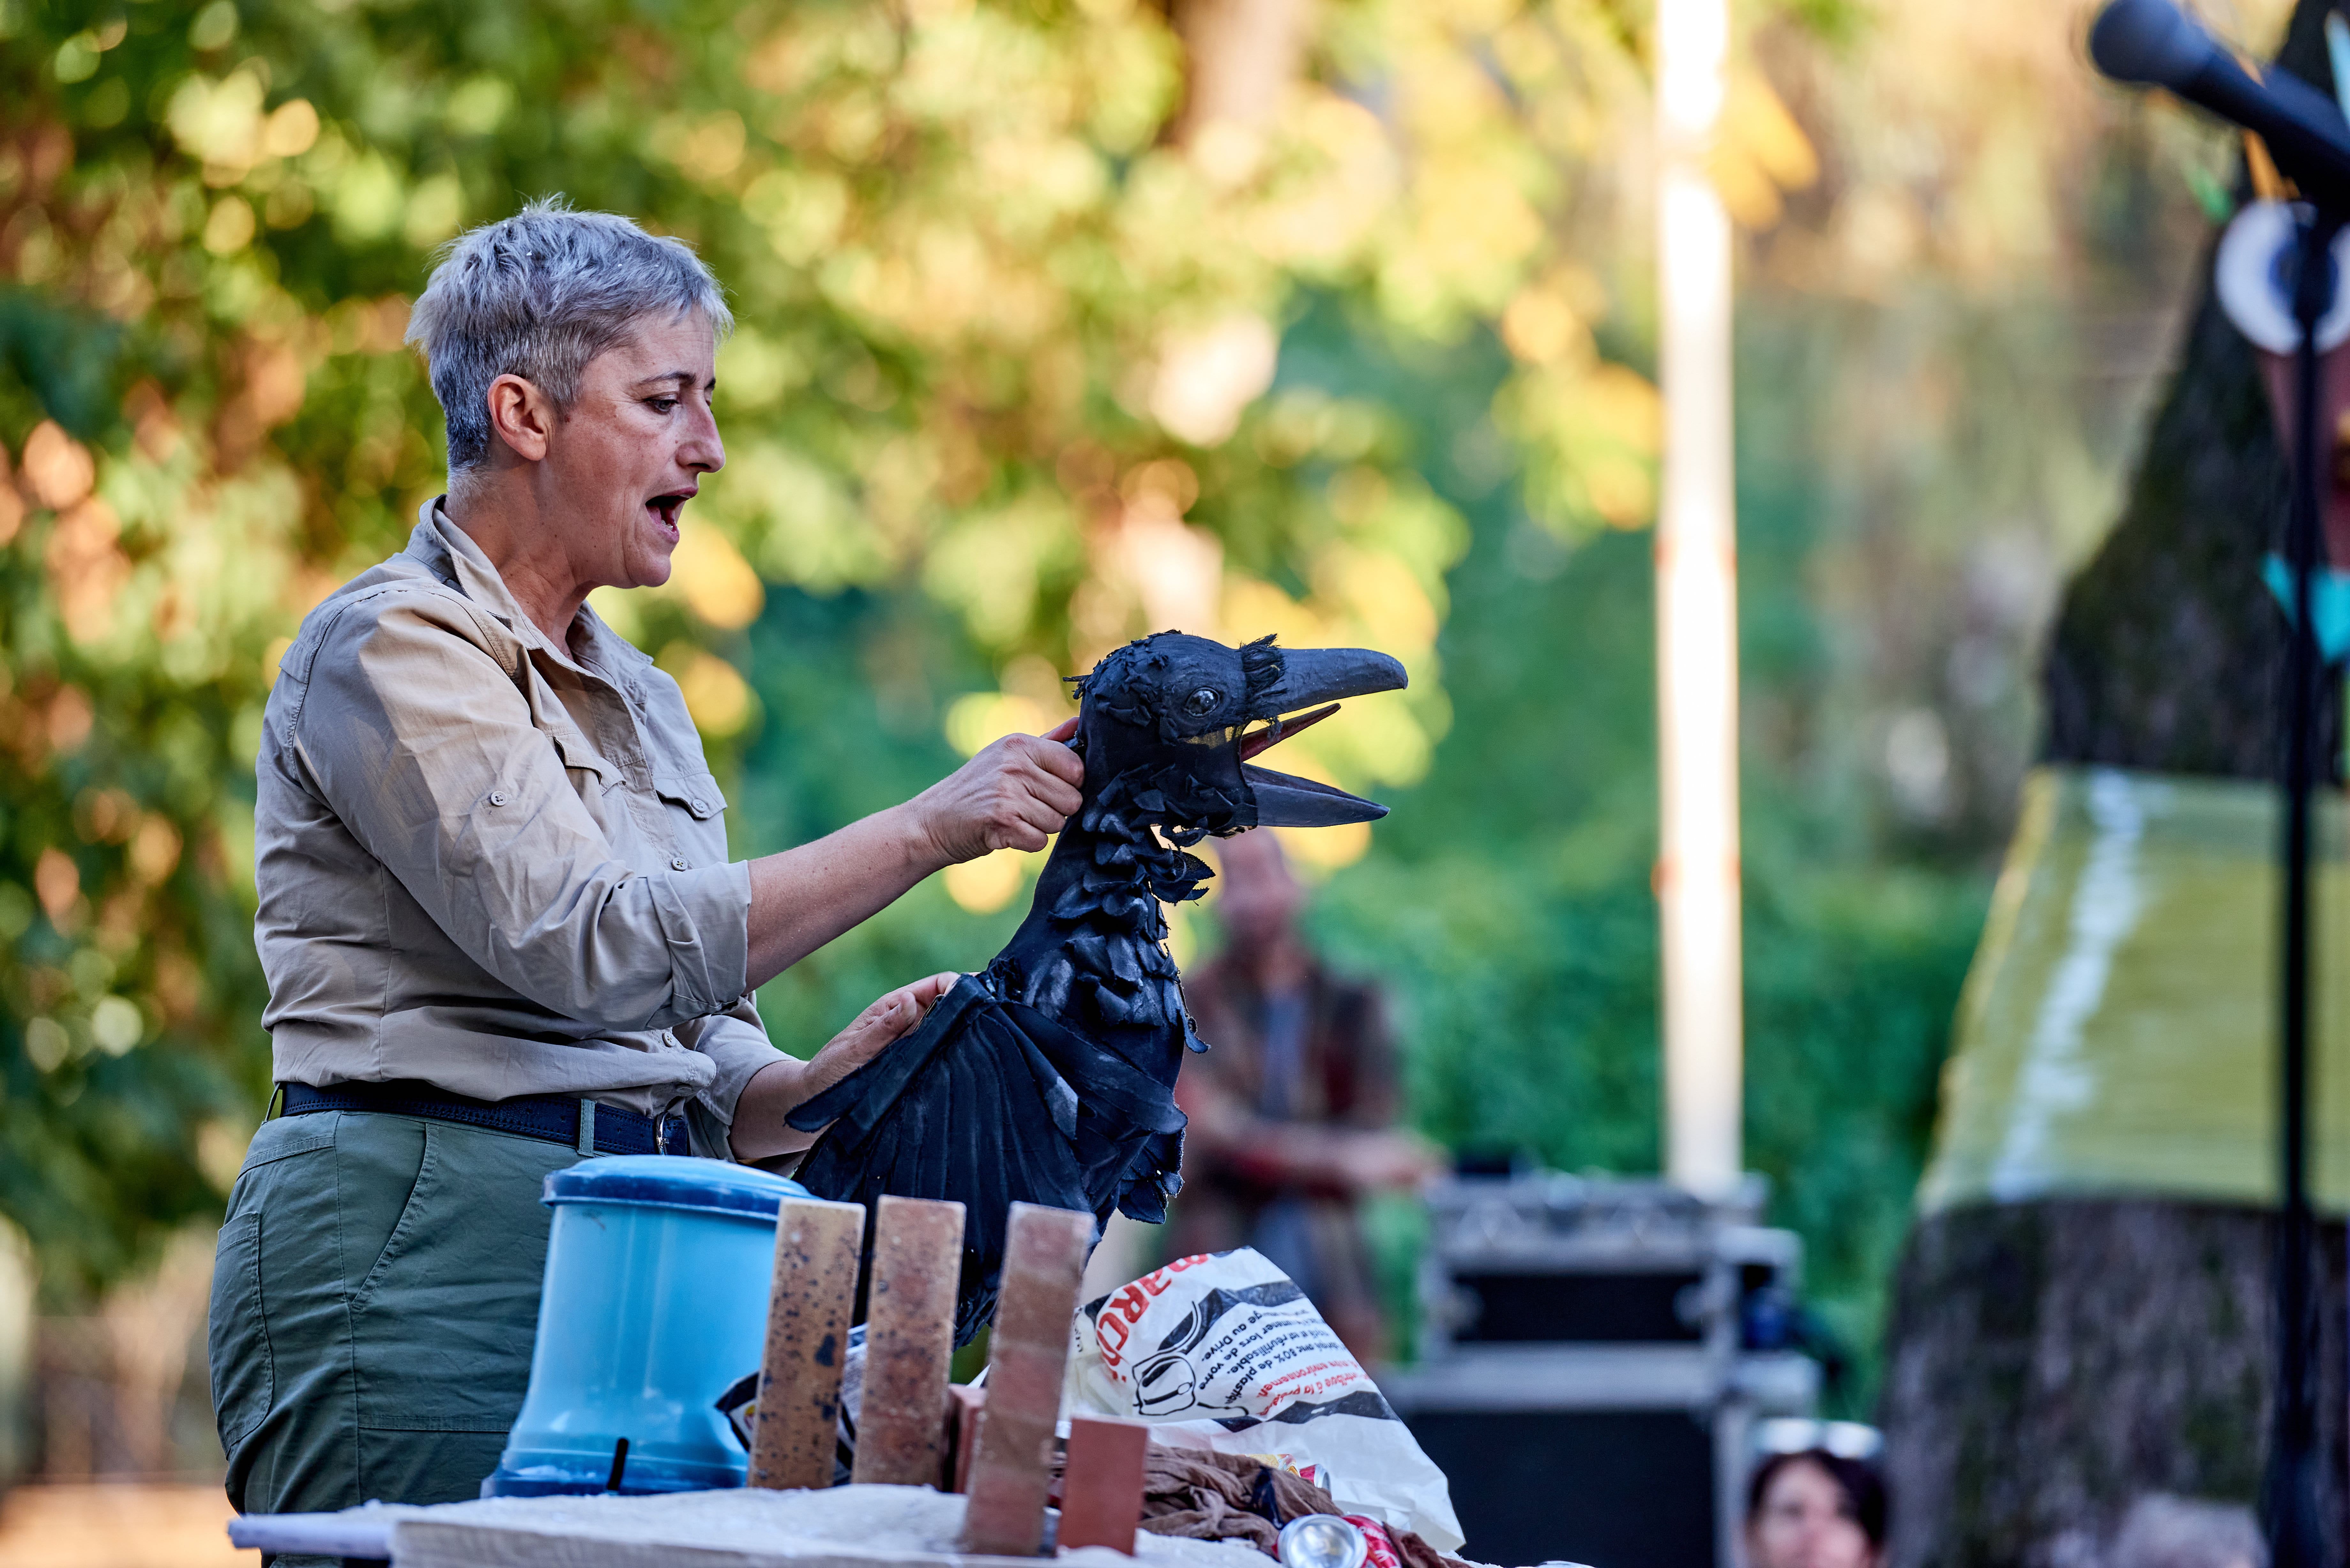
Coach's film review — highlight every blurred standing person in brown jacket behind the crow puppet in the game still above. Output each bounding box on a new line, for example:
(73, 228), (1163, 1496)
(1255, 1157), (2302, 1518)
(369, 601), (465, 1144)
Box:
(1168, 827), (1441, 1361)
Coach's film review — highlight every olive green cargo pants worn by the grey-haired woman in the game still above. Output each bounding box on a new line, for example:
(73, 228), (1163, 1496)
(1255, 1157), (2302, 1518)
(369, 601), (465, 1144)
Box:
(211, 1112), (578, 1523)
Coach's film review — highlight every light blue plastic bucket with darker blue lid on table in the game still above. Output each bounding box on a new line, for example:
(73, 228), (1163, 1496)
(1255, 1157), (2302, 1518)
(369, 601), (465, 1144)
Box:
(482, 1154), (806, 1497)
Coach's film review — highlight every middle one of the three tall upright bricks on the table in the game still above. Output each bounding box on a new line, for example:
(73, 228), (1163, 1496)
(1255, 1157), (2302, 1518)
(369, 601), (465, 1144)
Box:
(851, 1196), (964, 1486)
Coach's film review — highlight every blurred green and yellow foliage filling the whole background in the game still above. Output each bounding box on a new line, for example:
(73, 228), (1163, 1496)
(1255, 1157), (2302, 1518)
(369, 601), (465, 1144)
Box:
(0, 0), (2218, 1420)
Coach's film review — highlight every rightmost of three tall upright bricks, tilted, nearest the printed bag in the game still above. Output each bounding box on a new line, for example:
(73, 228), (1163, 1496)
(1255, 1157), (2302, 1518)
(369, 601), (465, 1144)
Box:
(964, 1204), (1095, 1556)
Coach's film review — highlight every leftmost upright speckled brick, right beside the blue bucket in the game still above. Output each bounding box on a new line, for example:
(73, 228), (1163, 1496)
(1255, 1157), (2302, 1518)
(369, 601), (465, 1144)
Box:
(750, 1199), (865, 1488)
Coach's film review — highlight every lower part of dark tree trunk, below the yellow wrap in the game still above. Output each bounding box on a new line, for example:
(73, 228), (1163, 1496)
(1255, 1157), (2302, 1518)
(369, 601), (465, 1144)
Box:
(1885, 1199), (2345, 1568)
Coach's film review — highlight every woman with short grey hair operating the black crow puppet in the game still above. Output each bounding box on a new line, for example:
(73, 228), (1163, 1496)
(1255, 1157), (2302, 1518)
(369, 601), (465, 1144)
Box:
(211, 202), (1083, 1523)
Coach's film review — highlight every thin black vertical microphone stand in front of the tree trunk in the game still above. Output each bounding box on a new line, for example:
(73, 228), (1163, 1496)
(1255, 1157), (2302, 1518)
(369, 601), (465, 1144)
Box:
(2261, 207), (2341, 1568)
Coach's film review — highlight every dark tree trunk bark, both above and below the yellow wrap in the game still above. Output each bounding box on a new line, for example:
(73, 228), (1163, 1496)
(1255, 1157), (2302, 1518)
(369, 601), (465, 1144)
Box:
(1880, 0), (2350, 1568)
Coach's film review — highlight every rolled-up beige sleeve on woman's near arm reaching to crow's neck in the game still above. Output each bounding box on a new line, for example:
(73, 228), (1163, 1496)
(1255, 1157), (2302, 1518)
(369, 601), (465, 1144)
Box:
(294, 592), (750, 1034)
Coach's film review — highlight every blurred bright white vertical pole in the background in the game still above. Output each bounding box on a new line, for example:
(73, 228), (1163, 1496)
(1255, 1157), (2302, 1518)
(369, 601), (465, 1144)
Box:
(1657, 0), (1744, 1196)
